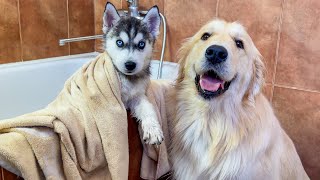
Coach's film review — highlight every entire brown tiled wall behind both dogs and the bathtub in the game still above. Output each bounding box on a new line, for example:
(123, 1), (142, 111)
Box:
(0, 0), (320, 179)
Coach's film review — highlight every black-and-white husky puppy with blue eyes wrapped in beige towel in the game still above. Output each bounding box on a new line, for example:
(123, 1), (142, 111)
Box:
(102, 2), (163, 144)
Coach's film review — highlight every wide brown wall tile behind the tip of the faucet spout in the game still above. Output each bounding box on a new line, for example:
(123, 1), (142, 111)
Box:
(20, 0), (69, 60)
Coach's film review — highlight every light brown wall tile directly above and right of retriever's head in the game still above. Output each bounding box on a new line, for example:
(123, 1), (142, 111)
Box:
(218, 0), (281, 83)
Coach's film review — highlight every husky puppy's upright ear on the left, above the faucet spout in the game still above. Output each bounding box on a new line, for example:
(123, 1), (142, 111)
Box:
(102, 2), (120, 34)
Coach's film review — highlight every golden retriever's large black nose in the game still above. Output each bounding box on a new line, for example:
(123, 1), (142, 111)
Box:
(206, 45), (228, 64)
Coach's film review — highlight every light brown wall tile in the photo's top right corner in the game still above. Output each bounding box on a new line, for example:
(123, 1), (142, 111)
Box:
(276, 0), (320, 91)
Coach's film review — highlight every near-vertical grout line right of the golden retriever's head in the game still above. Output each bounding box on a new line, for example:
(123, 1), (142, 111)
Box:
(271, 0), (285, 103)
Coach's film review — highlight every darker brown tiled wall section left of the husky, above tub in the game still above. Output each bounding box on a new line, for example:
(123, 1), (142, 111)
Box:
(0, 0), (94, 63)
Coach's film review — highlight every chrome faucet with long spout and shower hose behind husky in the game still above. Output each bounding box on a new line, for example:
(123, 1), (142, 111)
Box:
(59, 0), (167, 79)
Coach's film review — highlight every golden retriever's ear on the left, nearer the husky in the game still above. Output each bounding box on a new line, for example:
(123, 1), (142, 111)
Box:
(177, 38), (193, 84)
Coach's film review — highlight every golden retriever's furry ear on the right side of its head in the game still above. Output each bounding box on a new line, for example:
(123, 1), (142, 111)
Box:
(248, 53), (265, 102)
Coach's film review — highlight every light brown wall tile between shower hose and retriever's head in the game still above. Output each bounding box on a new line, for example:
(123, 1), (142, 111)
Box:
(164, 0), (217, 62)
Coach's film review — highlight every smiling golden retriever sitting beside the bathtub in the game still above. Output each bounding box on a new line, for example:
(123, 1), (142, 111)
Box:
(170, 20), (309, 180)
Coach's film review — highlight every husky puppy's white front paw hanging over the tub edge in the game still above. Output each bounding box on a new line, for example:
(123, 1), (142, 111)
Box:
(141, 121), (163, 145)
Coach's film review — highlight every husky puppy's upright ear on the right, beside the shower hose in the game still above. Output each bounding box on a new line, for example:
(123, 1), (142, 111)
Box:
(143, 6), (160, 38)
